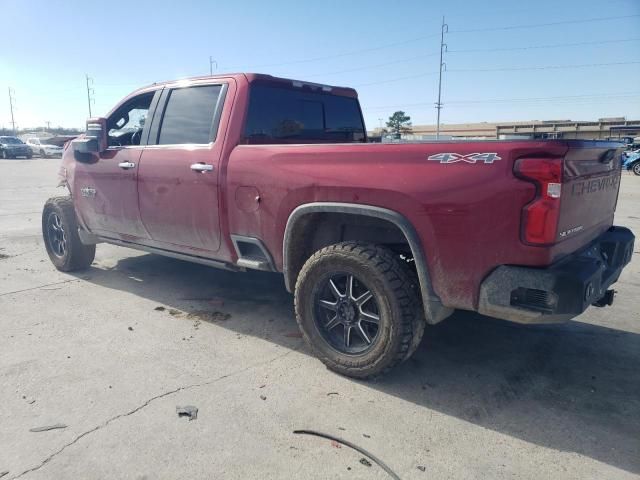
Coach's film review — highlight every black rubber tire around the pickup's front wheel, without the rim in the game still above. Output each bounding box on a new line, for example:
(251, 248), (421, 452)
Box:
(42, 197), (96, 272)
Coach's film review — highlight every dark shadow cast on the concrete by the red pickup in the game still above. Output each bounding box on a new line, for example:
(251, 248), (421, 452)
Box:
(76, 254), (640, 473)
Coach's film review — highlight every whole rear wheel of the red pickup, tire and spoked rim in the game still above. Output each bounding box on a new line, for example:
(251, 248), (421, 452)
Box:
(295, 242), (424, 378)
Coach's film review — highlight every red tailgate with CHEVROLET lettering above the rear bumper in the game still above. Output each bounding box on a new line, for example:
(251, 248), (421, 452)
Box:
(557, 141), (622, 242)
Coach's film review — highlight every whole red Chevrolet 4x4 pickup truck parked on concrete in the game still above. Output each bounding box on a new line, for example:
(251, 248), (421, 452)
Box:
(42, 74), (634, 378)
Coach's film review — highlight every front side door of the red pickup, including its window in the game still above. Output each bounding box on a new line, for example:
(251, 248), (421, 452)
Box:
(73, 90), (160, 243)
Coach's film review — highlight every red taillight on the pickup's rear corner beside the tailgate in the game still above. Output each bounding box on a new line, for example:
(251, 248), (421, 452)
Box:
(514, 158), (562, 245)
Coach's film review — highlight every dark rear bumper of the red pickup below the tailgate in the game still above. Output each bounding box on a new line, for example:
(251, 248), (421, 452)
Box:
(478, 227), (635, 323)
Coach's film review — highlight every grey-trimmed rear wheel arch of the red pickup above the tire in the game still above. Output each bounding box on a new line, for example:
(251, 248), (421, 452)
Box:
(282, 202), (453, 324)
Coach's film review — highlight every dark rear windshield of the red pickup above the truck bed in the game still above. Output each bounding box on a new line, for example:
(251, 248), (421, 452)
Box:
(244, 84), (366, 144)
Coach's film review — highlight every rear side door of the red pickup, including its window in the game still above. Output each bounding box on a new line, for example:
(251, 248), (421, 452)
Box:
(138, 82), (227, 256)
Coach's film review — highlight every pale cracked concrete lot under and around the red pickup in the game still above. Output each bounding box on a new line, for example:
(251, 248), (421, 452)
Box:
(0, 159), (640, 480)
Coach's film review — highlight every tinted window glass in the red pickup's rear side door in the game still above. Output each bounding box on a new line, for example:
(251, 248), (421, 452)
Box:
(158, 85), (222, 145)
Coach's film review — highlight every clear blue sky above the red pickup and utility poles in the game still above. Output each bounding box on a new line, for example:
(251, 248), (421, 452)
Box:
(0, 0), (640, 128)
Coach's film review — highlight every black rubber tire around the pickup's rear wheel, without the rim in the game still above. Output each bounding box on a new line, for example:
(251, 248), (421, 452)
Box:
(295, 242), (425, 379)
